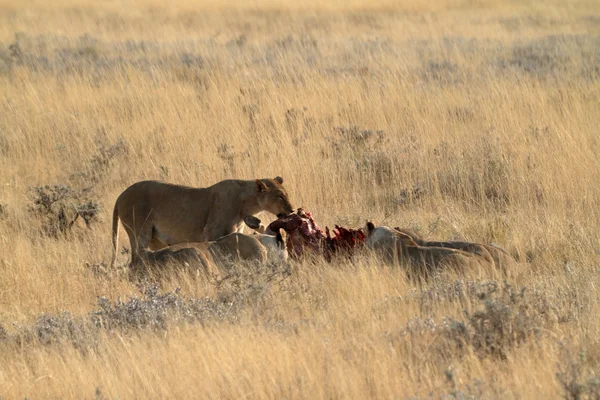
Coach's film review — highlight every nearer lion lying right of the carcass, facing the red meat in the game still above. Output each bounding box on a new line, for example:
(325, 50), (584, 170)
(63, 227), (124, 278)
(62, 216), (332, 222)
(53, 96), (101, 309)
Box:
(364, 221), (493, 276)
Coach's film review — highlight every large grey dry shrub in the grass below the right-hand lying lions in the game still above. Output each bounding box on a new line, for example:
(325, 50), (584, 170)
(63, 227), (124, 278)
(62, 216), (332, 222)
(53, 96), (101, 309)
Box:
(401, 281), (562, 360)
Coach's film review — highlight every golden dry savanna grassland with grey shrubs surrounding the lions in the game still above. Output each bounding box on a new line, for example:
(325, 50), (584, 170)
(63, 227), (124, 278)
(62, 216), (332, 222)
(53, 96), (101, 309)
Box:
(0, 0), (600, 399)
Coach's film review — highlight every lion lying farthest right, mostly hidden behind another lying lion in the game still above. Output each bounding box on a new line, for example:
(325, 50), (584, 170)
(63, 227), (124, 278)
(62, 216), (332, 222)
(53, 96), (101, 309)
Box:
(394, 228), (515, 272)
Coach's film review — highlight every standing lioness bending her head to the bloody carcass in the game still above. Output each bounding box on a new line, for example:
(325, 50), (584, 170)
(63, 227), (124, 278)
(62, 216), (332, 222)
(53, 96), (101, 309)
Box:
(111, 176), (294, 266)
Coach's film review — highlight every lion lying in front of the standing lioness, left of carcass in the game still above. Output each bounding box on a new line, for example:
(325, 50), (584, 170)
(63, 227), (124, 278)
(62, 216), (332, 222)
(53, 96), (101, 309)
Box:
(131, 229), (288, 277)
